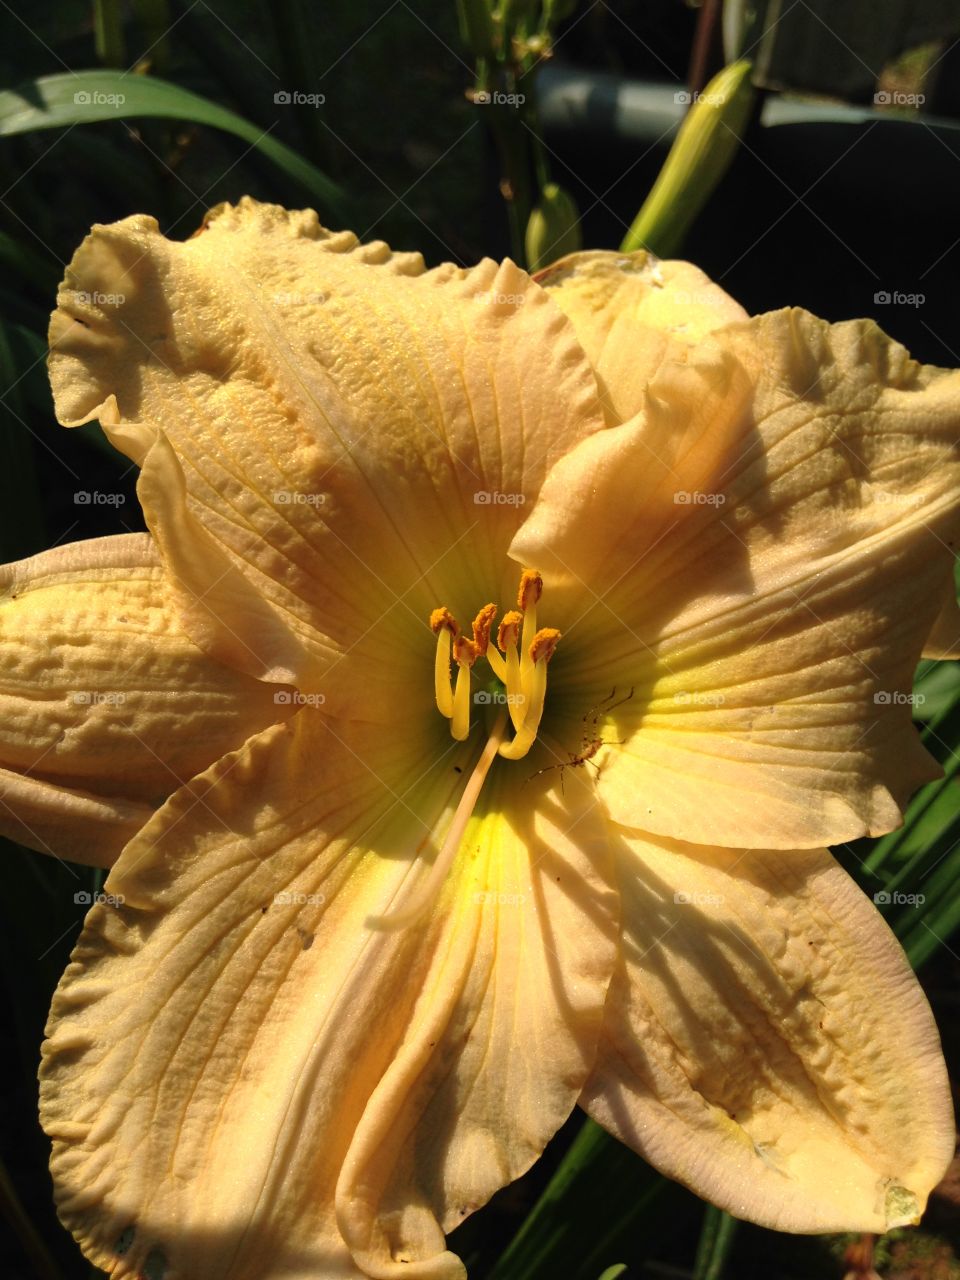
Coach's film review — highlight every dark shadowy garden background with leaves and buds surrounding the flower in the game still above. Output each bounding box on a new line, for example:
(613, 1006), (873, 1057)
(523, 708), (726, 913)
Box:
(0, 0), (960, 1280)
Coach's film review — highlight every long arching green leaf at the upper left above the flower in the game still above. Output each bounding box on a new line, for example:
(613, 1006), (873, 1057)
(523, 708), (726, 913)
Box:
(0, 70), (351, 225)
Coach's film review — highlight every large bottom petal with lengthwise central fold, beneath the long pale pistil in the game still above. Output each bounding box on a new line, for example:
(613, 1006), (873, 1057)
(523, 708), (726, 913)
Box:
(42, 708), (617, 1280)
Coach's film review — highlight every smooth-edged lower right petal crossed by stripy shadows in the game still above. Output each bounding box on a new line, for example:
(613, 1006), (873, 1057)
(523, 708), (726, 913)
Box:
(582, 831), (954, 1233)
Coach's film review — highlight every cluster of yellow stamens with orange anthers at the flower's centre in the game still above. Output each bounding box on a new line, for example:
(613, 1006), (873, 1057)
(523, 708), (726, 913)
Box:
(430, 568), (561, 760)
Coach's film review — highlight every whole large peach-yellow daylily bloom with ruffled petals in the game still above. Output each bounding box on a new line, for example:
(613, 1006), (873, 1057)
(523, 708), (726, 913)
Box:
(0, 200), (960, 1280)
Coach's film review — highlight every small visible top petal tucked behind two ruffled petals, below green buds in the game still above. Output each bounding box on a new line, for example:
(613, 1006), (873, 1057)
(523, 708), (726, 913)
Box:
(535, 250), (748, 425)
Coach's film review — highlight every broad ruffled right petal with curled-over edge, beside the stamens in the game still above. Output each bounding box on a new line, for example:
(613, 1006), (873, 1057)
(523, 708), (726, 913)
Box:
(522, 312), (960, 849)
